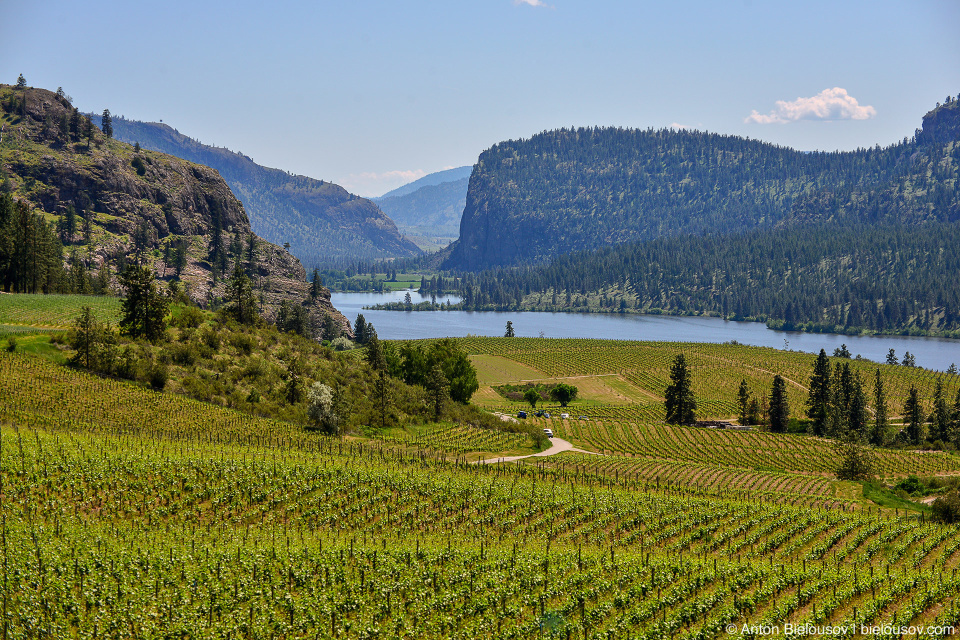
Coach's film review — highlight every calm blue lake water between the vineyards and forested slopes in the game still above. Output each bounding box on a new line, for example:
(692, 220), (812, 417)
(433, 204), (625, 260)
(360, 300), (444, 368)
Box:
(332, 291), (960, 371)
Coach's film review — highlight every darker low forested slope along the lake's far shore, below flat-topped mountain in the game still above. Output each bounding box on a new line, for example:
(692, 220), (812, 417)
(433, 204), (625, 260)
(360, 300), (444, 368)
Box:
(444, 223), (960, 336)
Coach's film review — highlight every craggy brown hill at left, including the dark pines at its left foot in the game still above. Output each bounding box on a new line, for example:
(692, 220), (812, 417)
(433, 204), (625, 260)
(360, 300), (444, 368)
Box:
(0, 85), (347, 328)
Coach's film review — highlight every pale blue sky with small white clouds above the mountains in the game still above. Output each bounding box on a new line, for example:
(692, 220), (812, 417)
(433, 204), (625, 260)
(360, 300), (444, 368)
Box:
(0, 0), (960, 196)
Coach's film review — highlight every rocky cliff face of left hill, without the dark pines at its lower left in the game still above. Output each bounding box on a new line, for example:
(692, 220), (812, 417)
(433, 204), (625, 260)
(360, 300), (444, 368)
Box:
(0, 85), (348, 328)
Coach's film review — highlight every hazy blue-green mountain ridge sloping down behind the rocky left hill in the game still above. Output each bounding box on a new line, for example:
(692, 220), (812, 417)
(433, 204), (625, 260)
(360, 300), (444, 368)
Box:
(90, 115), (420, 266)
